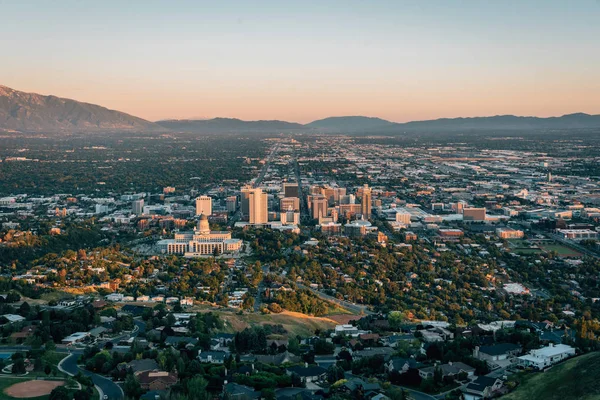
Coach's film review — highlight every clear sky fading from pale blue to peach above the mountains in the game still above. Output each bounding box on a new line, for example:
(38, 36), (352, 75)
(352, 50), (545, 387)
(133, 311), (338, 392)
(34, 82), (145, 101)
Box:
(0, 0), (600, 123)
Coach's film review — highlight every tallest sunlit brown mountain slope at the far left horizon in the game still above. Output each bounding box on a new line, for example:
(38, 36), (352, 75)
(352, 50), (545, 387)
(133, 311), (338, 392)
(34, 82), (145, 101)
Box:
(0, 86), (165, 132)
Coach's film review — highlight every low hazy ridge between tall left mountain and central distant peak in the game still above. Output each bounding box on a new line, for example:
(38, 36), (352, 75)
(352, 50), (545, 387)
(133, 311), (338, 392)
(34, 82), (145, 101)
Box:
(157, 118), (306, 133)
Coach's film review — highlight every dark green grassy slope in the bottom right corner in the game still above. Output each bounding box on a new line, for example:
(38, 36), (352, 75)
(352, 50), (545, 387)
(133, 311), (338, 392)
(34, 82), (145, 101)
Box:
(502, 352), (600, 400)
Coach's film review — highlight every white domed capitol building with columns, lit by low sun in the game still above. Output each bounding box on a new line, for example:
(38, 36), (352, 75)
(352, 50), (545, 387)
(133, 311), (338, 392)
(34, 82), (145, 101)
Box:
(158, 214), (242, 257)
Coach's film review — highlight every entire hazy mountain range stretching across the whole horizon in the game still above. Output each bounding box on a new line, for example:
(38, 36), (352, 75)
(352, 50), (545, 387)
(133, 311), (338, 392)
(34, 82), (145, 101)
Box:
(0, 85), (600, 135)
